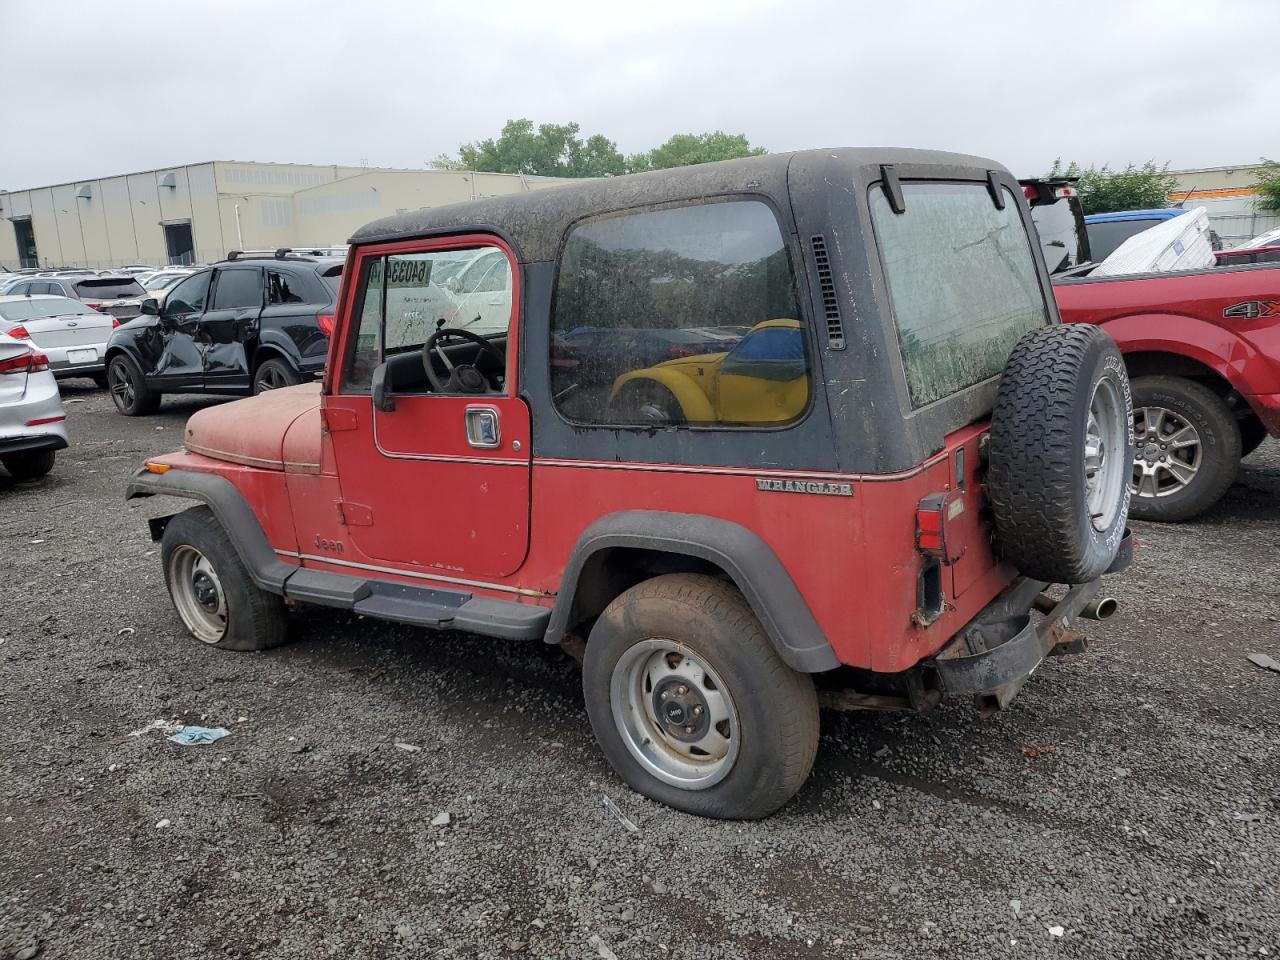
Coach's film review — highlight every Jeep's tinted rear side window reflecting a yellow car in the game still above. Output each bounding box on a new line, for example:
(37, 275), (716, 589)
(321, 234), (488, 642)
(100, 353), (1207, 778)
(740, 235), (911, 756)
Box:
(552, 200), (810, 426)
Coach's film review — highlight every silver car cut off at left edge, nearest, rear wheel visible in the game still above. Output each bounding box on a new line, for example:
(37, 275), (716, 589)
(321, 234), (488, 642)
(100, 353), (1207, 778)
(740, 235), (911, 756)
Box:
(0, 333), (67, 480)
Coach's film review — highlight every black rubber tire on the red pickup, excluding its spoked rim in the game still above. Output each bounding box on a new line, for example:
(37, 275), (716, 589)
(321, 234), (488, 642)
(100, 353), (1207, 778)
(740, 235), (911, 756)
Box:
(1133, 376), (1243, 521)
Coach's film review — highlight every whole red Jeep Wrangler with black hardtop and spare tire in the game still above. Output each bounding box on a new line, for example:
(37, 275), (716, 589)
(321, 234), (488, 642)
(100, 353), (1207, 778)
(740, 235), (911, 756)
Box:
(129, 150), (1133, 818)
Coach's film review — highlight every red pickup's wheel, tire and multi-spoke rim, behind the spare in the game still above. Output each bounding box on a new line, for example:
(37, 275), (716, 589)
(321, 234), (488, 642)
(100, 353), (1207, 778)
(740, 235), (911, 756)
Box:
(1133, 376), (1242, 521)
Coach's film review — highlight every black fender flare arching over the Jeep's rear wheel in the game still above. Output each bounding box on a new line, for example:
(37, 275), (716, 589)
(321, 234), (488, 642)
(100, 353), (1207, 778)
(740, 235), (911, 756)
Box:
(545, 509), (840, 673)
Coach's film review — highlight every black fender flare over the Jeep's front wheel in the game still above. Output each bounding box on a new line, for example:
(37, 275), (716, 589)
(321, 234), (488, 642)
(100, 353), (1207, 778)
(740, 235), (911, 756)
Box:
(124, 467), (298, 595)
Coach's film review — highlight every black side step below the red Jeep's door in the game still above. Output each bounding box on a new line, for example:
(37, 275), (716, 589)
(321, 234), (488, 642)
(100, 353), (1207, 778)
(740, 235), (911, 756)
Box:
(284, 568), (552, 640)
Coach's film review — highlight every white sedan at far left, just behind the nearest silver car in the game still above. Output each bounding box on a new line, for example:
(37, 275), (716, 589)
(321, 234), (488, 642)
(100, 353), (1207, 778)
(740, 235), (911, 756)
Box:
(0, 296), (118, 385)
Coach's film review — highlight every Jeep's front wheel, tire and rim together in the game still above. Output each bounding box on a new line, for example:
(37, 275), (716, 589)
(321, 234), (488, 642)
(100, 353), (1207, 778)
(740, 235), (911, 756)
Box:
(160, 507), (287, 650)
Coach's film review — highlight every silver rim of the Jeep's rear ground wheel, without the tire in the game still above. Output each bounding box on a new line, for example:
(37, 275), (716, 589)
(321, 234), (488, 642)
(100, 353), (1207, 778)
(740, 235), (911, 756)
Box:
(609, 639), (741, 790)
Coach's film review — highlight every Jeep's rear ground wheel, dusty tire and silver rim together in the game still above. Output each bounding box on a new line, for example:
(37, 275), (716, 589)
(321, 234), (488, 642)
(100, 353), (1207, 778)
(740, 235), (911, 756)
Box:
(582, 573), (818, 819)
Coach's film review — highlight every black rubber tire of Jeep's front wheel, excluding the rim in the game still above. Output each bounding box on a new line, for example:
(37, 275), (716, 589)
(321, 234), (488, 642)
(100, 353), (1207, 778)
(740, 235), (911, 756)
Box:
(160, 507), (288, 650)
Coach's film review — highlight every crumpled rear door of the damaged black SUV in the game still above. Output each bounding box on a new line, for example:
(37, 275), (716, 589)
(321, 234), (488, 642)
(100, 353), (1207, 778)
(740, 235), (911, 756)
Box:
(200, 266), (262, 392)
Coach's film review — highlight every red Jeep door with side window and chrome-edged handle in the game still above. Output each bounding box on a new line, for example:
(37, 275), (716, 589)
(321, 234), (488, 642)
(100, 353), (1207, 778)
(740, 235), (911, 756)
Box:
(325, 236), (530, 584)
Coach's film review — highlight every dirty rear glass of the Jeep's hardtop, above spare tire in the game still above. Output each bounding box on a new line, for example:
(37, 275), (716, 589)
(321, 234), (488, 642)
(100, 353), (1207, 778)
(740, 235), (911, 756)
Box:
(870, 183), (1050, 407)
